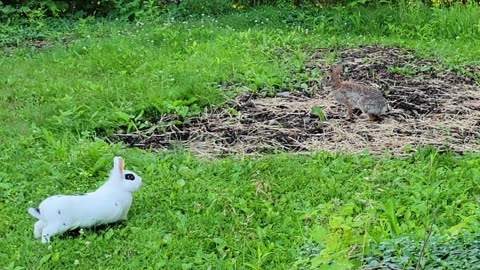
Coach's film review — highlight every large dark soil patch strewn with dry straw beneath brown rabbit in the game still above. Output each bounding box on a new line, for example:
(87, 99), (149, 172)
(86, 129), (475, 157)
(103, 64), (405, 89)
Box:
(113, 46), (480, 156)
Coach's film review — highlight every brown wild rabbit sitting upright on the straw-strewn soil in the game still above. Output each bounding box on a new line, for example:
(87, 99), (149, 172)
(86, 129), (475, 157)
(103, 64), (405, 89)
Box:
(322, 64), (388, 120)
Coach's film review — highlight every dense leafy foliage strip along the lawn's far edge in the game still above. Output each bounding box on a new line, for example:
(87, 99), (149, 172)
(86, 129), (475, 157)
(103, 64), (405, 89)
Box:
(0, 0), (478, 19)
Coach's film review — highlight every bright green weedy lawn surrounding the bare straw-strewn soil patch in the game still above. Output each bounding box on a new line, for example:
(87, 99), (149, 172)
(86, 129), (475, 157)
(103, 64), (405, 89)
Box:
(0, 3), (480, 269)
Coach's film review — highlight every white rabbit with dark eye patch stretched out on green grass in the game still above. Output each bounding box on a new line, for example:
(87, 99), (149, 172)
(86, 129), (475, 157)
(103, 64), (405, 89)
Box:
(28, 157), (142, 243)
